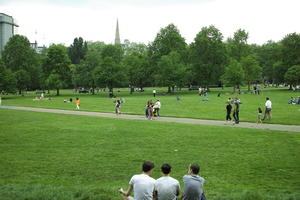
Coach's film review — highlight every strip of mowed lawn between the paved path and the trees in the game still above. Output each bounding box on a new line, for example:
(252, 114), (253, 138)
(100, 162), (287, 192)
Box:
(2, 88), (300, 125)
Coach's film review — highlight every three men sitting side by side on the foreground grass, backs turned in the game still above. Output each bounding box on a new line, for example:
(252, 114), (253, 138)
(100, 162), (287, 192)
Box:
(118, 161), (206, 200)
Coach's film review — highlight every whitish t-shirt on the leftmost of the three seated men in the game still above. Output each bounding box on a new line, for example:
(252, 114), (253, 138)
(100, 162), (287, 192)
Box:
(129, 174), (155, 200)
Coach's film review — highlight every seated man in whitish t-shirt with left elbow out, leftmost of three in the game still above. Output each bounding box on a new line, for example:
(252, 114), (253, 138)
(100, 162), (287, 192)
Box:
(119, 161), (155, 200)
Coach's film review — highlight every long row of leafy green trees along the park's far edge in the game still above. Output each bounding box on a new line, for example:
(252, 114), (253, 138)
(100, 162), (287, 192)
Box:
(0, 24), (300, 95)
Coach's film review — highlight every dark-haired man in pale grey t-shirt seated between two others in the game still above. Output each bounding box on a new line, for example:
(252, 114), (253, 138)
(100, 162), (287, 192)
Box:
(154, 163), (180, 200)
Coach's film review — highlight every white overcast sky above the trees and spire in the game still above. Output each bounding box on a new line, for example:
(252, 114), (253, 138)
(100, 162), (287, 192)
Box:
(0, 0), (300, 45)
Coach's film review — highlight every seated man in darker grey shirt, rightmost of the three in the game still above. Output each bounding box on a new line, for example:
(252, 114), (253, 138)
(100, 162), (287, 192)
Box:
(183, 164), (205, 200)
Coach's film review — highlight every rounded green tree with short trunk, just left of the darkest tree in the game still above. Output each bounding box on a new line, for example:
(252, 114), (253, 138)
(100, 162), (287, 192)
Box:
(43, 45), (71, 95)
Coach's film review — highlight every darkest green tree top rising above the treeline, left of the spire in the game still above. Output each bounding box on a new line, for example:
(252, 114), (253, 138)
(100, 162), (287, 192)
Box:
(68, 37), (88, 64)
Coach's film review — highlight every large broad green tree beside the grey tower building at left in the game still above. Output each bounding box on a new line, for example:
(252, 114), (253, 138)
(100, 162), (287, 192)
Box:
(2, 35), (41, 94)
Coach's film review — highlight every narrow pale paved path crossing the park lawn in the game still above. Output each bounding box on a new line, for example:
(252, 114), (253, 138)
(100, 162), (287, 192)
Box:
(0, 106), (300, 132)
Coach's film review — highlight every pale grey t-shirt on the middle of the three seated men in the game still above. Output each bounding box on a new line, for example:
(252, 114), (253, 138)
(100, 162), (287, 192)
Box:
(155, 176), (180, 200)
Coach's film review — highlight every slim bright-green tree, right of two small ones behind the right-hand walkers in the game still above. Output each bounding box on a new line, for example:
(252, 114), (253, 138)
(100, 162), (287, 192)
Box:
(241, 55), (262, 91)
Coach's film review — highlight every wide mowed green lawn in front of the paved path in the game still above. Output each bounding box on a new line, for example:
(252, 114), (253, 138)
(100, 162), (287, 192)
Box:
(0, 109), (300, 200)
